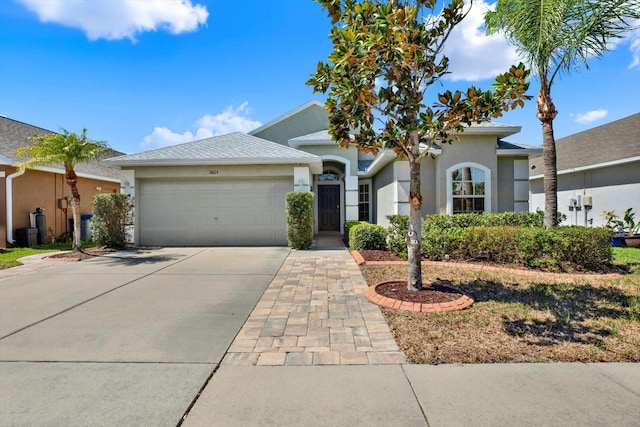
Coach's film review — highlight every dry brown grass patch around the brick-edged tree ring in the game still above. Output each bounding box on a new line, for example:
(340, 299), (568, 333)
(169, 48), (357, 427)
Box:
(361, 264), (640, 364)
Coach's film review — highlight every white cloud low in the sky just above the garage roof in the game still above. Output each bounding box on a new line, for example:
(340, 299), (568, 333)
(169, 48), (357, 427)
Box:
(140, 102), (262, 150)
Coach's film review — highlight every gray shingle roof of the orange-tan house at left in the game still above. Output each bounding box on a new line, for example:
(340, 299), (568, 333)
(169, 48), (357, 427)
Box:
(0, 116), (119, 180)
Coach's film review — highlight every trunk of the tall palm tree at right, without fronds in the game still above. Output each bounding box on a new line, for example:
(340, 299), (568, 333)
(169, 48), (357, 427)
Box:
(538, 84), (558, 229)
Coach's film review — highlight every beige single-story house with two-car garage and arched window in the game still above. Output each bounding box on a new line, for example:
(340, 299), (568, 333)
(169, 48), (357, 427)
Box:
(102, 101), (542, 246)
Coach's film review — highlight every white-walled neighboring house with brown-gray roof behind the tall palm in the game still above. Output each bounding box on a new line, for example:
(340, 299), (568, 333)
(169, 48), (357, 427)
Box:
(529, 113), (640, 226)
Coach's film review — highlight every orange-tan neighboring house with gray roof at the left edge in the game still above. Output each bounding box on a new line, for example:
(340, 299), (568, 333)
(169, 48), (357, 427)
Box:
(0, 116), (120, 248)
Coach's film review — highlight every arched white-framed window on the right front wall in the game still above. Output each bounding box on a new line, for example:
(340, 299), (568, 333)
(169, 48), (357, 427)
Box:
(447, 162), (491, 214)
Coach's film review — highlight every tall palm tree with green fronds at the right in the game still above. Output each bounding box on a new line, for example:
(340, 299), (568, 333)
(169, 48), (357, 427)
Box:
(485, 0), (640, 228)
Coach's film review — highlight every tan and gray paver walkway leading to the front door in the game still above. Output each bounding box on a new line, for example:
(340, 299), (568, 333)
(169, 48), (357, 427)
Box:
(222, 235), (406, 366)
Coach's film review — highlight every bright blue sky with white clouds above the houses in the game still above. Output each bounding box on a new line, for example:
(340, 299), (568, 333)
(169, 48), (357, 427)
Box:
(0, 0), (640, 153)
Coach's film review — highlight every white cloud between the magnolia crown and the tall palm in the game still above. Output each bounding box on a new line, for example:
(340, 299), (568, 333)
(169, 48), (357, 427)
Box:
(444, 0), (521, 81)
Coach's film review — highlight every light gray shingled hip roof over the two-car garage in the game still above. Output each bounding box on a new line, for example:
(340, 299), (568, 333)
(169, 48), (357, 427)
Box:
(103, 132), (321, 166)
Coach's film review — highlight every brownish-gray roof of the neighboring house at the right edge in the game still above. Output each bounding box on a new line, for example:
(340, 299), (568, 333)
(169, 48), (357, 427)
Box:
(529, 113), (640, 175)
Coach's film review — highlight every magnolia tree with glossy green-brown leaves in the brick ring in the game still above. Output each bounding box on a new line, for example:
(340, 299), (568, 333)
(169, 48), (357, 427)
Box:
(307, 0), (529, 291)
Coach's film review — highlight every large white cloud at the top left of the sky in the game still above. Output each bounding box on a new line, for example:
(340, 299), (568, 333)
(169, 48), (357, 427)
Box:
(18, 0), (209, 41)
